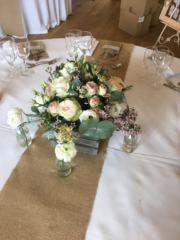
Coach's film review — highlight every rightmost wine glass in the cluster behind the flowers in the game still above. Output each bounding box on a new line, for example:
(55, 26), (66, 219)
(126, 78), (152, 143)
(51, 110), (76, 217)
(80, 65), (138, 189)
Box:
(80, 31), (93, 57)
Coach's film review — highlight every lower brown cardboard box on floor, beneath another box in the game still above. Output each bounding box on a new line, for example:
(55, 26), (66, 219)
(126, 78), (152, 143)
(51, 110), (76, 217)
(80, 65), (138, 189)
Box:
(119, 9), (152, 37)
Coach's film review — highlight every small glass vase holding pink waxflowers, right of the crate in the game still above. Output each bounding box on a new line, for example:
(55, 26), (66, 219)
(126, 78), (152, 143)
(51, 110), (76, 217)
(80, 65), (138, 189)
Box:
(122, 134), (138, 153)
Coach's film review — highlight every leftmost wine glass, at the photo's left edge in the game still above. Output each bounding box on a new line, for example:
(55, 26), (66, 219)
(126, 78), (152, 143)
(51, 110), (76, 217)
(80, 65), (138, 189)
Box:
(0, 37), (21, 78)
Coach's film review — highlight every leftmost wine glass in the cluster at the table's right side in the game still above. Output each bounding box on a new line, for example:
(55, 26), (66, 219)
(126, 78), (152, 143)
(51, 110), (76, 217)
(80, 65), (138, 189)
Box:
(139, 46), (156, 83)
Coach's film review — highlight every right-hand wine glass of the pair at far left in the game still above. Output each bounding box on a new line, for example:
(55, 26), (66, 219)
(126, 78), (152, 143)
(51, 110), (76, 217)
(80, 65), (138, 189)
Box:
(14, 37), (35, 76)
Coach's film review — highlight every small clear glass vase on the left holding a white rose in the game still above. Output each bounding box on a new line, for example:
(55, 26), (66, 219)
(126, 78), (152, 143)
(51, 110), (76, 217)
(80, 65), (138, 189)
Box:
(16, 127), (32, 148)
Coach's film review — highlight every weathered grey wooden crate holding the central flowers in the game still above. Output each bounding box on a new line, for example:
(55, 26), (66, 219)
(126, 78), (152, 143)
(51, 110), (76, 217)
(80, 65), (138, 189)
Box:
(50, 131), (100, 155)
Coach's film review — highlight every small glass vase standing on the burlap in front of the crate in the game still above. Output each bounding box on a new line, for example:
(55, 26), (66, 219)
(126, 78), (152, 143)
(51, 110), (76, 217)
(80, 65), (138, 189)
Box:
(56, 158), (71, 178)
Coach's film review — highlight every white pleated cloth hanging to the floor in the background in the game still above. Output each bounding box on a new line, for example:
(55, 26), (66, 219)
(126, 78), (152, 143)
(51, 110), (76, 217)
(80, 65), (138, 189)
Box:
(0, 0), (72, 38)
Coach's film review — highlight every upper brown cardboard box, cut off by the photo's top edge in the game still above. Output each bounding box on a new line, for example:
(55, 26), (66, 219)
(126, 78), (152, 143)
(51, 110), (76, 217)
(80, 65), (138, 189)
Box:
(121, 0), (159, 16)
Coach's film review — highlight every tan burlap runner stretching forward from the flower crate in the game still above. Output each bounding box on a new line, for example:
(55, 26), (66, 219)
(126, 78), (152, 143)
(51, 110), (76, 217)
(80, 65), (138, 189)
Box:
(0, 41), (132, 240)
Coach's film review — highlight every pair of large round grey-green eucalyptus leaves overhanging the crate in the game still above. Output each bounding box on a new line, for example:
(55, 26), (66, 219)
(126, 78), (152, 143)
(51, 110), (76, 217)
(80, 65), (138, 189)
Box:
(79, 119), (116, 139)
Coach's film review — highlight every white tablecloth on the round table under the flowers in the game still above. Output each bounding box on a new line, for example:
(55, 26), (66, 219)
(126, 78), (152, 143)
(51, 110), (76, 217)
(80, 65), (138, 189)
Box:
(0, 39), (180, 240)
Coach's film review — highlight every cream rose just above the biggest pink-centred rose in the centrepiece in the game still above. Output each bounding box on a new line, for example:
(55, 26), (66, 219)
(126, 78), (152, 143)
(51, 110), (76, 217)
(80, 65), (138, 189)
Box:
(49, 77), (69, 98)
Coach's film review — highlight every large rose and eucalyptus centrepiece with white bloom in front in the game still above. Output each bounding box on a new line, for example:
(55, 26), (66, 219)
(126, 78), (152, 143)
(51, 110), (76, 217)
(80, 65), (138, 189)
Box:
(6, 53), (140, 161)
